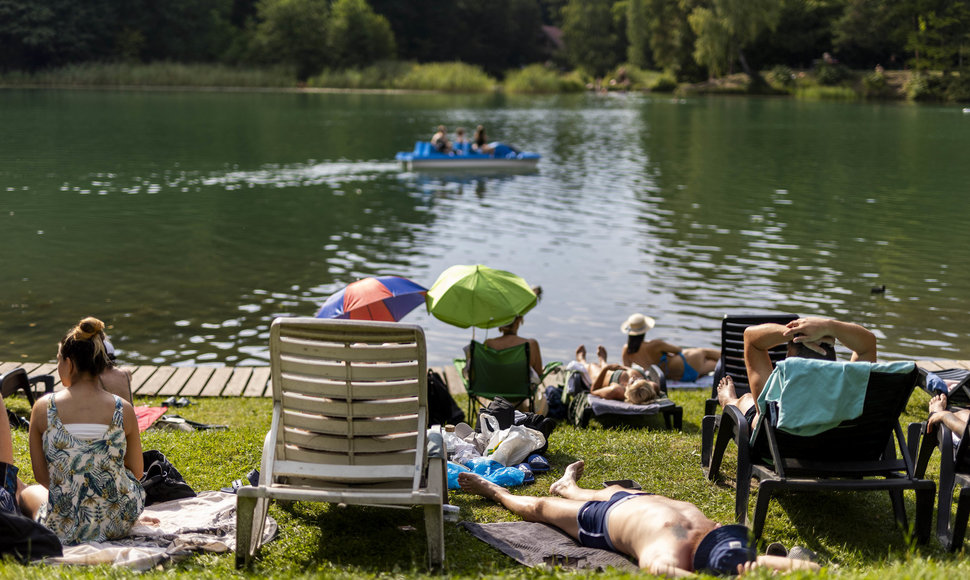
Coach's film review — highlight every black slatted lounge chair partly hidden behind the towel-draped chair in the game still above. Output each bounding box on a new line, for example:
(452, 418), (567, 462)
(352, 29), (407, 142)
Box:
(701, 314), (798, 473)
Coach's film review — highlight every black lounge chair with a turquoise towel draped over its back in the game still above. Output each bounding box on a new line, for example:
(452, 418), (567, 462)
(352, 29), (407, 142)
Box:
(707, 365), (936, 543)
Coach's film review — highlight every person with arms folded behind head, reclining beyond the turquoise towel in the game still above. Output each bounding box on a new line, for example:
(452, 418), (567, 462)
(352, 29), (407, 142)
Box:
(717, 317), (876, 425)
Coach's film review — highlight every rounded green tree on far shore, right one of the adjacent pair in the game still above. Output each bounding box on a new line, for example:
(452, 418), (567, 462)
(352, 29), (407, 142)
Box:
(327, 0), (395, 68)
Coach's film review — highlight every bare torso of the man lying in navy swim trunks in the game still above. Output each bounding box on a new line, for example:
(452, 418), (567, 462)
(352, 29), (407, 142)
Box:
(608, 495), (717, 573)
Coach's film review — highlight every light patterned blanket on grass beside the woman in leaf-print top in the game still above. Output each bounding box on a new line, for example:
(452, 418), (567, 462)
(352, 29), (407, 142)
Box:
(43, 491), (276, 570)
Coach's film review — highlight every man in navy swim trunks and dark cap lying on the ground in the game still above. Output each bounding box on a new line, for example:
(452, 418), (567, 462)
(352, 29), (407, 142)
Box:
(458, 461), (819, 576)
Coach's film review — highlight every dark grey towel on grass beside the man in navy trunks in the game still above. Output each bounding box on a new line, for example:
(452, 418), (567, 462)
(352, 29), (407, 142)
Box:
(461, 522), (639, 572)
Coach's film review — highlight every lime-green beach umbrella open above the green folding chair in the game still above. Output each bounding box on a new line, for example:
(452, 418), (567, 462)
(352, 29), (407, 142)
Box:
(425, 265), (538, 328)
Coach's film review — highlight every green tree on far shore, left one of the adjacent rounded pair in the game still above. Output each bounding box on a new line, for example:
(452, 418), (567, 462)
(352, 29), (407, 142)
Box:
(253, 0), (330, 81)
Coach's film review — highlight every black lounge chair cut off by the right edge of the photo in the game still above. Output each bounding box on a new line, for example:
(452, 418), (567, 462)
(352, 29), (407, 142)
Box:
(910, 412), (970, 552)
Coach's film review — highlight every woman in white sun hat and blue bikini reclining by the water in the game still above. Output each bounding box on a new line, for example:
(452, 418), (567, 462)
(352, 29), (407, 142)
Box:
(620, 312), (721, 382)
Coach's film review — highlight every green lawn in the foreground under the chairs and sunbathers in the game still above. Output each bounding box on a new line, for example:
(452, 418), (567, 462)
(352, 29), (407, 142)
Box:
(0, 382), (970, 579)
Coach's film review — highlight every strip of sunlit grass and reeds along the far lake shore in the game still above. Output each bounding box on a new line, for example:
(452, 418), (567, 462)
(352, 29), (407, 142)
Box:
(0, 61), (970, 103)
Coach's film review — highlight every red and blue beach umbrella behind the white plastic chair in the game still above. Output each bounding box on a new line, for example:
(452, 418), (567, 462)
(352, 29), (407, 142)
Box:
(317, 276), (428, 322)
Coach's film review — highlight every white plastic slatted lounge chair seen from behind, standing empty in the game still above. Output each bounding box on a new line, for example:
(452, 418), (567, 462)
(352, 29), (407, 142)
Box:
(236, 318), (448, 567)
